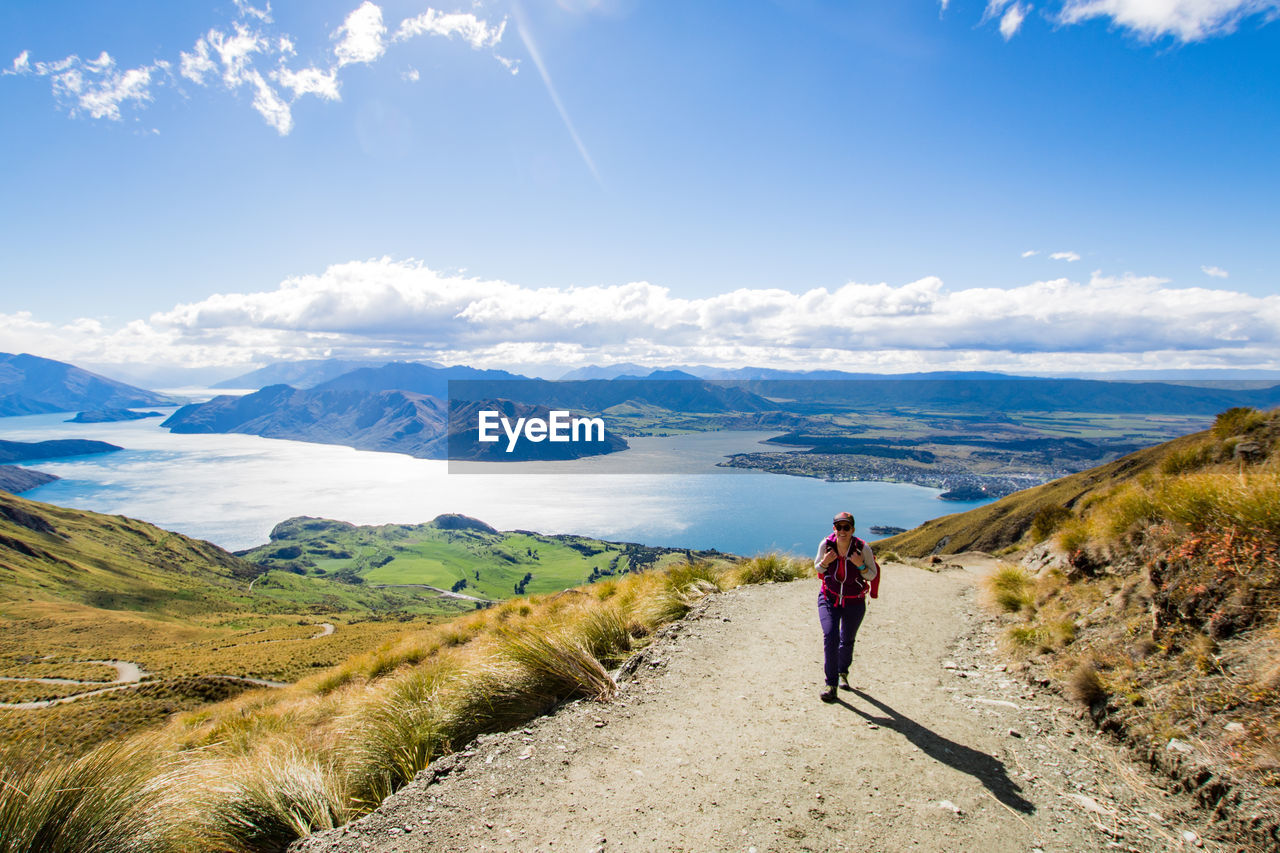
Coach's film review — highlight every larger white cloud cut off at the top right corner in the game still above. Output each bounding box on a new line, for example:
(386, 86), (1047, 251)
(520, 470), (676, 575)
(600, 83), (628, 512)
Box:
(1059, 0), (1280, 42)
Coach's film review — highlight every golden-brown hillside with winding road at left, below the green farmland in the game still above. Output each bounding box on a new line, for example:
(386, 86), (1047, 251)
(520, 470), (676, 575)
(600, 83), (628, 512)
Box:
(0, 492), (474, 758)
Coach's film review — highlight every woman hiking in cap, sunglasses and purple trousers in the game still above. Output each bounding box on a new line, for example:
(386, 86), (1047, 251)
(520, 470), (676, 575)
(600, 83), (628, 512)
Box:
(813, 512), (879, 702)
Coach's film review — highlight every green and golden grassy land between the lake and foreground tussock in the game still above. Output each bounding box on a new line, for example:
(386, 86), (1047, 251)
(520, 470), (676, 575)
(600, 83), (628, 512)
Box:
(0, 492), (727, 754)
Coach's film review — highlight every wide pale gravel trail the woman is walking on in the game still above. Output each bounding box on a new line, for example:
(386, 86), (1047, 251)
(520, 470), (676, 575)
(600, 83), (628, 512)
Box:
(293, 556), (1222, 853)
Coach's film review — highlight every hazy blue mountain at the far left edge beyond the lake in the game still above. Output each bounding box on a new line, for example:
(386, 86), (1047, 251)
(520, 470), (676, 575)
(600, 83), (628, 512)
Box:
(0, 352), (177, 418)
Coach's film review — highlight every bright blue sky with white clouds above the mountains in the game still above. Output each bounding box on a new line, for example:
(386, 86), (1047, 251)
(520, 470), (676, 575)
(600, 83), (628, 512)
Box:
(0, 0), (1280, 374)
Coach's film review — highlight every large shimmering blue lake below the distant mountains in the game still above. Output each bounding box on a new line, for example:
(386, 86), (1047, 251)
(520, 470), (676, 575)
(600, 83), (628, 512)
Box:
(0, 411), (988, 555)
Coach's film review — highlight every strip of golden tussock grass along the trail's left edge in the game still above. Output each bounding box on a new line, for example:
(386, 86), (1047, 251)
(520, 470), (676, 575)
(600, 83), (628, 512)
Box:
(0, 556), (768, 853)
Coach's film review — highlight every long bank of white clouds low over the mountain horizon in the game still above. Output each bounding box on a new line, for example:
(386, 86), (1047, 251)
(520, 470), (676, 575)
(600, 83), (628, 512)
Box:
(0, 257), (1280, 371)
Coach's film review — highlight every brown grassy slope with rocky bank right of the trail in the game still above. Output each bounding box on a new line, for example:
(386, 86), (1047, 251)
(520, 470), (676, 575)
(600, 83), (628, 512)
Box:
(879, 407), (1280, 849)
